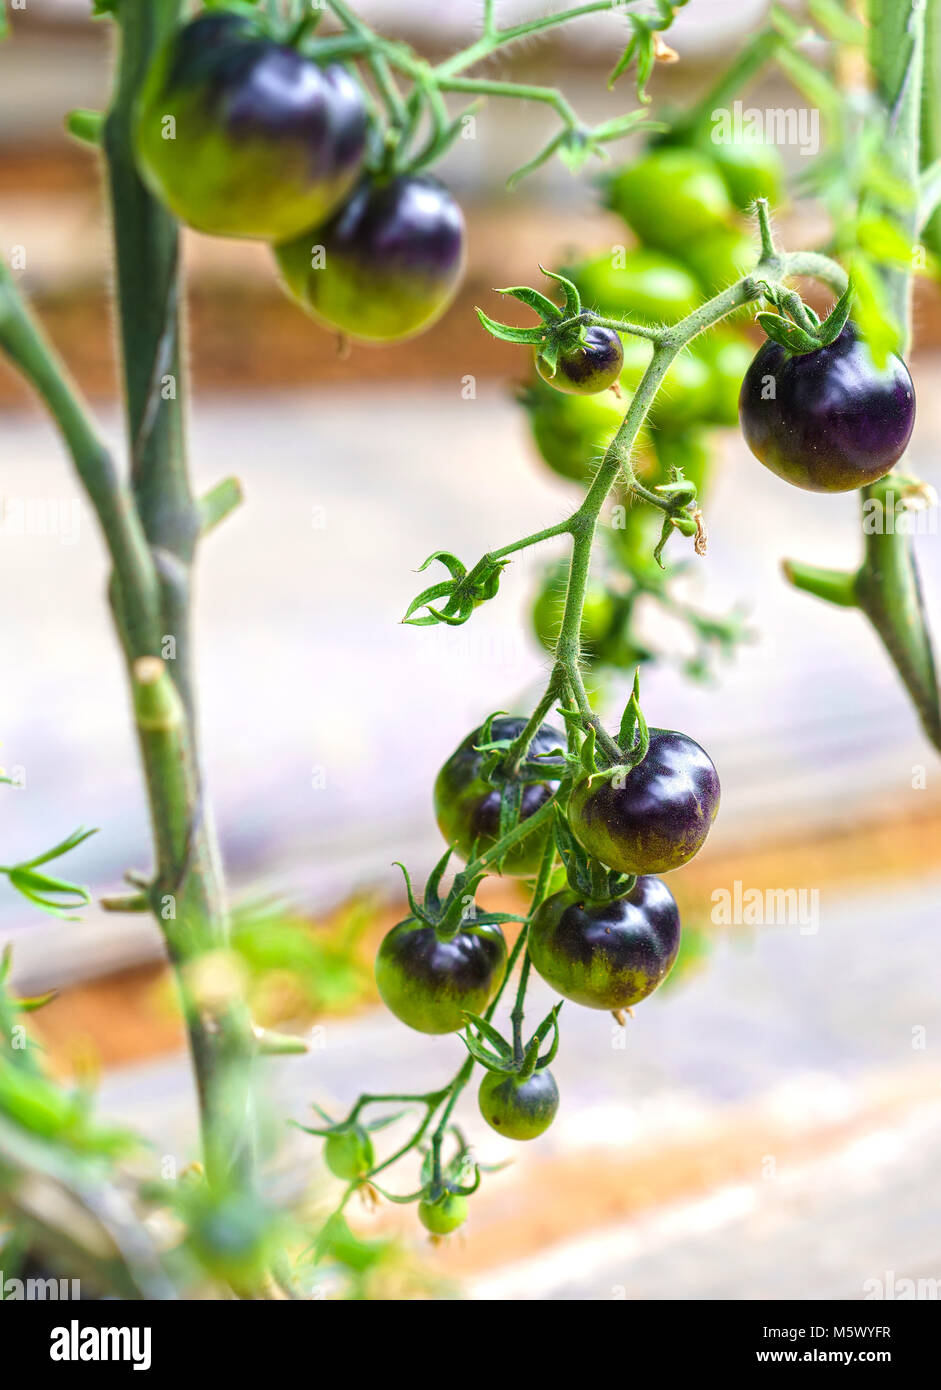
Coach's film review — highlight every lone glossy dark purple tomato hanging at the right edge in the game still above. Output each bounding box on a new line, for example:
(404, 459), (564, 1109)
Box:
(738, 324), (915, 492)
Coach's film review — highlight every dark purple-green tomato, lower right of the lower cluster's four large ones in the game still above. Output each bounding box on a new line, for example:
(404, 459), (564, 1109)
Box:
(528, 877), (680, 1009)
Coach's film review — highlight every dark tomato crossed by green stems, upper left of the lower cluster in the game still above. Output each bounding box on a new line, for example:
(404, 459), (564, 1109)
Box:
(434, 716), (566, 878)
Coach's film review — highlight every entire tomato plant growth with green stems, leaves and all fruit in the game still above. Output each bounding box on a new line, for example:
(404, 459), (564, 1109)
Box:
(0, 0), (941, 1297)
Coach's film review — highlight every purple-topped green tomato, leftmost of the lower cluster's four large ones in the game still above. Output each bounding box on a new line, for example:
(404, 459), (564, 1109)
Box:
(375, 917), (506, 1033)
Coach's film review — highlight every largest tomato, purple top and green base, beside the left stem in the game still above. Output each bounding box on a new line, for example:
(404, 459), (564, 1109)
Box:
(135, 13), (367, 240)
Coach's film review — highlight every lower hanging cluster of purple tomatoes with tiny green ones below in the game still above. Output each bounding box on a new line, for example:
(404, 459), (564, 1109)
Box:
(366, 700), (720, 1236)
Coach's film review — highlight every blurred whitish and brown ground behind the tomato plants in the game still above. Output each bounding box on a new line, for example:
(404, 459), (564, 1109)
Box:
(0, 0), (941, 1300)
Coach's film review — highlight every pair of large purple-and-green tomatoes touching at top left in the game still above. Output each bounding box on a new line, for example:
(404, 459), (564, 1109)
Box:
(136, 11), (464, 343)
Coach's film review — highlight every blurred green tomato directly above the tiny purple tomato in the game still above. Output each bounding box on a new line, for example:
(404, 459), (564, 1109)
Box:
(566, 246), (702, 324)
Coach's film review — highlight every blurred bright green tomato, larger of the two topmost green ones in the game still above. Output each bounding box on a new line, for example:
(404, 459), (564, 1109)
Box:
(607, 146), (733, 257)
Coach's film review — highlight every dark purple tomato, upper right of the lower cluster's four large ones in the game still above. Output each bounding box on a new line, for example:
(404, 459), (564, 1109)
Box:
(568, 728), (720, 873)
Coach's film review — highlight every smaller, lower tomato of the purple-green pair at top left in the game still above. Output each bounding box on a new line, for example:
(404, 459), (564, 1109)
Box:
(275, 174), (466, 343)
